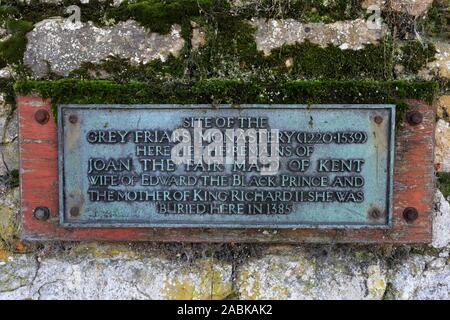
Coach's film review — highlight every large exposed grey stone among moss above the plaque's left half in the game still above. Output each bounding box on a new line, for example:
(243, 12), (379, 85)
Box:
(24, 18), (184, 76)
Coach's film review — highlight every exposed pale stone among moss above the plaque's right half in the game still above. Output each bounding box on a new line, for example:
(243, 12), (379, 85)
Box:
(252, 19), (386, 55)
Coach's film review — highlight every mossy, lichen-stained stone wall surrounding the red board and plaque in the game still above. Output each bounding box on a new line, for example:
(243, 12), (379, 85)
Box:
(0, 0), (450, 299)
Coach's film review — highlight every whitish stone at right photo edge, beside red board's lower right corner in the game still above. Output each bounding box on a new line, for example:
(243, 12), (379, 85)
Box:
(432, 190), (450, 248)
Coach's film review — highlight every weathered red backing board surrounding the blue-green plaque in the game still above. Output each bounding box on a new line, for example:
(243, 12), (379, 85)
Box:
(18, 96), (435, 243)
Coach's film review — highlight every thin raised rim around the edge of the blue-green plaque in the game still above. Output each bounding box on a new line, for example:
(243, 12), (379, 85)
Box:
(57, 104), (396, 229)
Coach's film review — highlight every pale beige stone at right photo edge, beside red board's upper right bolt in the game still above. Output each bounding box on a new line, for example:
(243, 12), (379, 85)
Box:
(435, 119), (450, 172)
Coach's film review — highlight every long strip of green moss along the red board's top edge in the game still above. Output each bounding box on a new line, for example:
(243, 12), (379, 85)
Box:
(15, 79), (438, 127)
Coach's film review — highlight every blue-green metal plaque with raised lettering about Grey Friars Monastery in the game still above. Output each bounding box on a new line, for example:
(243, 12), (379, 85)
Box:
(58, 104), (395, 228)
